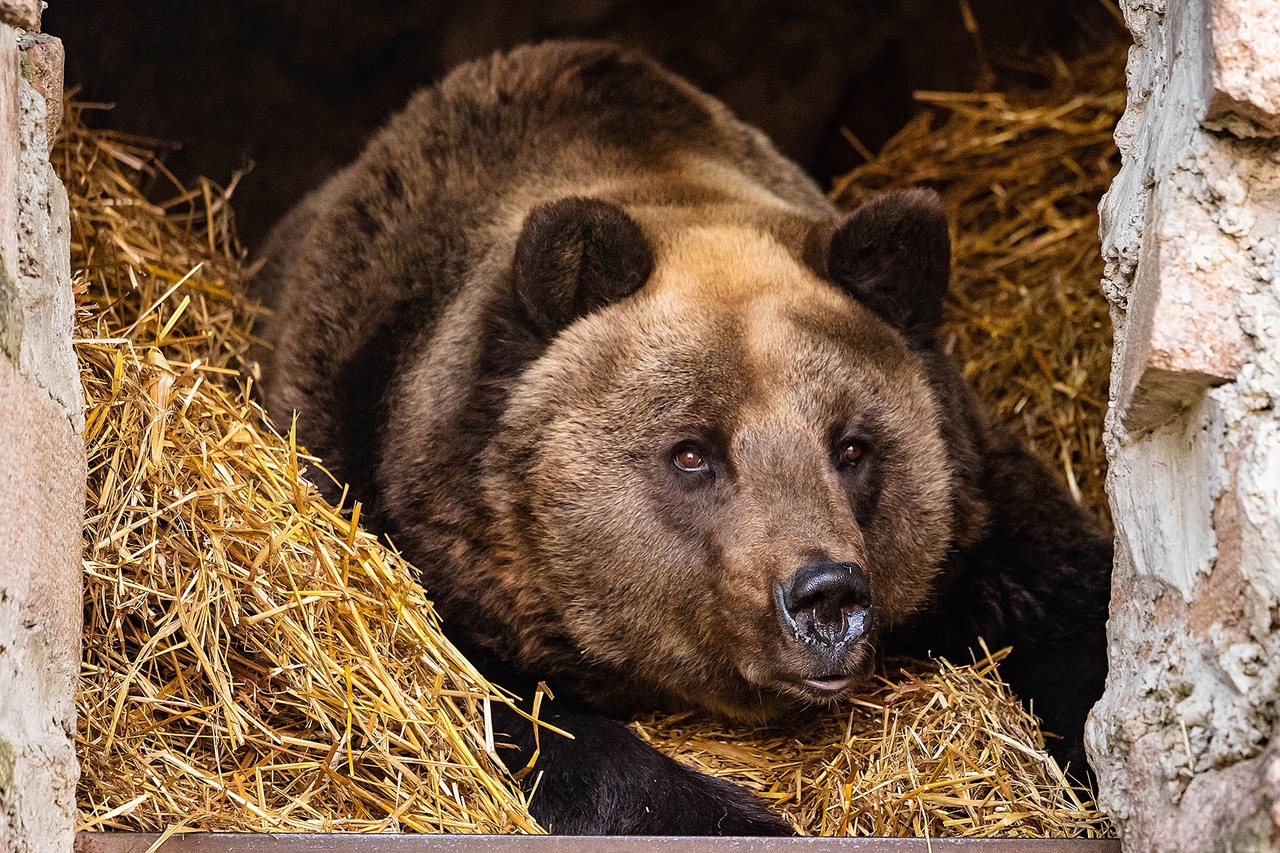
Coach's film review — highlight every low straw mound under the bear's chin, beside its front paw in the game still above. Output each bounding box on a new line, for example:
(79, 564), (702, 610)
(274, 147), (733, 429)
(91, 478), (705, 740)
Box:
(634, 649), (1110, 838)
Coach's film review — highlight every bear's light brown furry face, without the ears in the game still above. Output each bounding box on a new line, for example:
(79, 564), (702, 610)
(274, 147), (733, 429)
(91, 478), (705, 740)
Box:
(484, 192), (952, 719)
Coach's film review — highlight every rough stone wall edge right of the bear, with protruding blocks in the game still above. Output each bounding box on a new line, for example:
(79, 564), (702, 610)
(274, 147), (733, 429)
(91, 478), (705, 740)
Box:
(1088, 0), (1280, 853)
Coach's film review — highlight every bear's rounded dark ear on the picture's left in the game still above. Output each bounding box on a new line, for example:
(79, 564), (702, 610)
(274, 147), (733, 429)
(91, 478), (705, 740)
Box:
(511, 197), (653, 346)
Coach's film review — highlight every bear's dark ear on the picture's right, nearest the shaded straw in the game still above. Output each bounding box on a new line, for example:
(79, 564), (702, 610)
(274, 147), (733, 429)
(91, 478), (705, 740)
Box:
(826, 190), (951, 348)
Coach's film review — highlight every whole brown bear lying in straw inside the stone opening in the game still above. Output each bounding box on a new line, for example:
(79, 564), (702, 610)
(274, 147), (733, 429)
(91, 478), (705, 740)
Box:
(257, 42), (1111, 834)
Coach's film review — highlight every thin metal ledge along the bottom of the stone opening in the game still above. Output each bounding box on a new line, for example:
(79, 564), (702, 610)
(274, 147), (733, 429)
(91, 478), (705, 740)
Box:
(76, 833), (1120, 853)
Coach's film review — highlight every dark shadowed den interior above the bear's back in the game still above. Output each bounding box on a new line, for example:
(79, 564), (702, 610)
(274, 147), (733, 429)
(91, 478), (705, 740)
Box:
(44, 0), (1106, 247)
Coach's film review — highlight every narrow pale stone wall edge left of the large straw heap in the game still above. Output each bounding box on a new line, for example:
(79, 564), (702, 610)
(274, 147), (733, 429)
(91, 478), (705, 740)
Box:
(0, 0), (84, 853)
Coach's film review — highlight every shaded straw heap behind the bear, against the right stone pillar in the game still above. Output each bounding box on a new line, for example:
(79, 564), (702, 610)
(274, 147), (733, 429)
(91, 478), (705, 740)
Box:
(832, 39), (1125, 521)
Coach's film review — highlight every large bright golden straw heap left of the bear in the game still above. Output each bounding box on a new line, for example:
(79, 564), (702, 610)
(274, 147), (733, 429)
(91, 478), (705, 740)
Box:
(63, 109), (539, 833)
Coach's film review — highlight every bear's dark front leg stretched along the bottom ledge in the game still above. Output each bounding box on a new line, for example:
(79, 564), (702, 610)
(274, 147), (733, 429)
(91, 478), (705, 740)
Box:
(493, 706), (794, 835)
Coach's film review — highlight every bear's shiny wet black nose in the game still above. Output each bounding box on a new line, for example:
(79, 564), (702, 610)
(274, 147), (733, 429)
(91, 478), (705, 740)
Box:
(778, 562), (872, 646)
